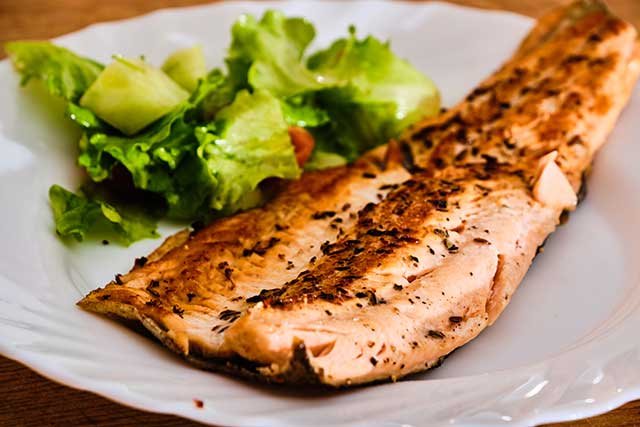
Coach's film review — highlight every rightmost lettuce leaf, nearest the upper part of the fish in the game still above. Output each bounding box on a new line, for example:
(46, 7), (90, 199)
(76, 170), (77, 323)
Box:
(308, 27), (440, 161)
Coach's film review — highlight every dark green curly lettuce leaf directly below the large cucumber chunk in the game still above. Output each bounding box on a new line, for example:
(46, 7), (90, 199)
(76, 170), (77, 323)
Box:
(78, 70), (233, 219)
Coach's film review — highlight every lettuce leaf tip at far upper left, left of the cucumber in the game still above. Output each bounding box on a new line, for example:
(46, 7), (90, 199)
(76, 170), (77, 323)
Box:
(5, 41), (104, 103)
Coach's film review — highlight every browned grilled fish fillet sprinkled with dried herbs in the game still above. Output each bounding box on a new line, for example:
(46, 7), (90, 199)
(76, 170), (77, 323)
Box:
(79, 1), (640, 386)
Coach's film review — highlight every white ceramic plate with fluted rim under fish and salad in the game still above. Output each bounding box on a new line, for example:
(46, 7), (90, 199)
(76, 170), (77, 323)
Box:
(0, 2), (640, 427)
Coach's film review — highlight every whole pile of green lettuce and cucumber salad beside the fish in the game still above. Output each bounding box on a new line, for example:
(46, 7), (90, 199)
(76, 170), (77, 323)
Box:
(5, 11), (440, 244)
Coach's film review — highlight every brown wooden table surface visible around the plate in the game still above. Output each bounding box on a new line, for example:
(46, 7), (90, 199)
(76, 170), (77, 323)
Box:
(0, 0), (640, 427)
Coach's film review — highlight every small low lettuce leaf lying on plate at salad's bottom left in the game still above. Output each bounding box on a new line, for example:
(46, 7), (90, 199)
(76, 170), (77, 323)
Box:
(49, 185), (159, 246)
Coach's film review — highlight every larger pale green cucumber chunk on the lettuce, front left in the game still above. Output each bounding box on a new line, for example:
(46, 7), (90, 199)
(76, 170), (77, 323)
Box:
(80, 57), (189, 135)
